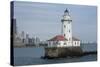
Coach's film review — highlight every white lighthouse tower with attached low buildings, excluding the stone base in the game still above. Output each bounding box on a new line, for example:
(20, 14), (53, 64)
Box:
(48, 9), (80, 47)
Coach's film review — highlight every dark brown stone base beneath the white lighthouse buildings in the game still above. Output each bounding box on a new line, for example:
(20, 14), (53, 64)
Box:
(45, 47), (83, 59)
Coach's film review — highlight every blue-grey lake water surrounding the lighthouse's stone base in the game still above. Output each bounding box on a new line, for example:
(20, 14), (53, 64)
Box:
(14, 45), (97, 66)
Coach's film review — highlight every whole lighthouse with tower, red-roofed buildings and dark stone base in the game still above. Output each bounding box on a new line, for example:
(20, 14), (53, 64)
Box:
(45, 9), (82, 58)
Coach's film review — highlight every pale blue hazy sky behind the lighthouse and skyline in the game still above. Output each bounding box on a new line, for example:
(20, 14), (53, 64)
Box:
(14, 1), (97, 42)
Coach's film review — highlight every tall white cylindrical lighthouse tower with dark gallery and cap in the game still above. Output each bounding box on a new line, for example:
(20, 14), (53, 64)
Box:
(61, 9), (72, 46)
